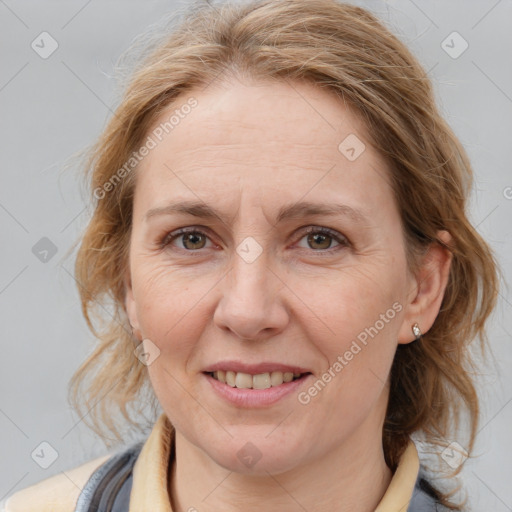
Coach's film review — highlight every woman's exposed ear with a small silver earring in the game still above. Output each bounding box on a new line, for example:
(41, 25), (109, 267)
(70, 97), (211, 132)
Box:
(398, 231), (452, 344)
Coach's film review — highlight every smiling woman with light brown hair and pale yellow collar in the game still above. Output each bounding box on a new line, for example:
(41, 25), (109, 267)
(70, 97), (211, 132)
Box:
(6, 0), (497, 512)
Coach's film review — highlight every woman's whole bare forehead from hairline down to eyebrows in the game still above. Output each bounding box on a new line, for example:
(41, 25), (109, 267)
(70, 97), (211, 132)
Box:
(136, 81), (389, 216)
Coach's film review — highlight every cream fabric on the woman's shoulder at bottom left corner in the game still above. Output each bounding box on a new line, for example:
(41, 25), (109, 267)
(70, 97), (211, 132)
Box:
(0, 454), (112, 512)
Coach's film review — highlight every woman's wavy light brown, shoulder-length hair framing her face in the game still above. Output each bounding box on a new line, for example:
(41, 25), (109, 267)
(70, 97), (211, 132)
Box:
(66, 0), (498, 510)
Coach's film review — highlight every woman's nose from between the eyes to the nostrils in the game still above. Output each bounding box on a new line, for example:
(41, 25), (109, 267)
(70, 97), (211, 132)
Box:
(214, 250), (289, 340)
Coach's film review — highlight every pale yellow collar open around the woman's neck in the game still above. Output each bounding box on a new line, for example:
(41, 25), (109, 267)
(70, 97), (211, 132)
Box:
(129, 413), (419, 512)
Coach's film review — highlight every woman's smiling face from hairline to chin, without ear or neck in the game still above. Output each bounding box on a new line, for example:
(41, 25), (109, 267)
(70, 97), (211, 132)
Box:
(126, 78), (413, 473)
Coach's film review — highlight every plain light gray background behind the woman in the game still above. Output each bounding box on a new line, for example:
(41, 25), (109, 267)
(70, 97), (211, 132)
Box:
(0, 0), (512, 512)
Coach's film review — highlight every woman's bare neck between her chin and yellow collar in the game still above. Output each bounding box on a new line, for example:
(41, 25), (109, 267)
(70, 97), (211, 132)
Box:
(169, 404), (392, 512)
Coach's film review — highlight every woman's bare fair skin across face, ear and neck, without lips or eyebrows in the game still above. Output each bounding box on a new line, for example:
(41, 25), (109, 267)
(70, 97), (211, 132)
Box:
(125, 80), (450, 512)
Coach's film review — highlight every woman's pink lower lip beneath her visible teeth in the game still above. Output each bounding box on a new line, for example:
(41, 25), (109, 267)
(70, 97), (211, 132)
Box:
(203, 373), (312, 407)
